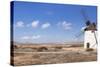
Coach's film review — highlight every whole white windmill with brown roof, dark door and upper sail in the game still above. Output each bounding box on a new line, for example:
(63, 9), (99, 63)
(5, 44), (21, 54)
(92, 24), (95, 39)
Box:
(82, 11), (98, 49)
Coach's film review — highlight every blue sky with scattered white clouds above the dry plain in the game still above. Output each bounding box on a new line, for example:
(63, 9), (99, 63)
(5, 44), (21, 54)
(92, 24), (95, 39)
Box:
(11, 1), (97, 43)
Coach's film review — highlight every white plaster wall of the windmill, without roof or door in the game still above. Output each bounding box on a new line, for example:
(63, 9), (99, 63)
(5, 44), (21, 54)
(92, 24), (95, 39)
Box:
(84, 30), (97, 48)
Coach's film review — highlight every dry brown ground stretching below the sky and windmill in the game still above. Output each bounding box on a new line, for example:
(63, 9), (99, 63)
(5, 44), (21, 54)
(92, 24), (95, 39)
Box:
(11, 45), (97, 66)
